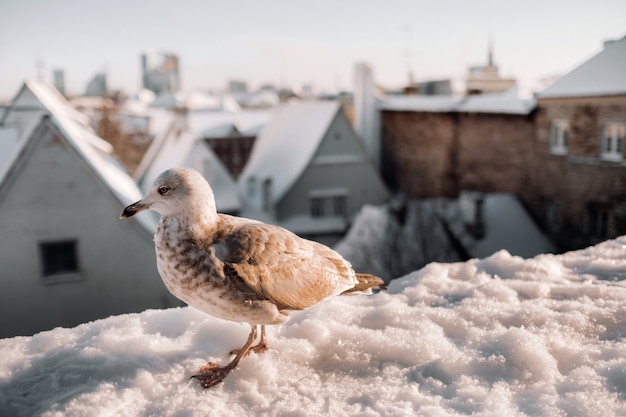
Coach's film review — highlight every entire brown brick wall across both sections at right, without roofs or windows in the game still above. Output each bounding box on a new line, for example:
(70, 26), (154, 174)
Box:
(383, 96), (626, 250)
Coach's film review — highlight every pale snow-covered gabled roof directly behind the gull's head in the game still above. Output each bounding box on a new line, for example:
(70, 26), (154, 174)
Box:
(138, 115), (241, 212)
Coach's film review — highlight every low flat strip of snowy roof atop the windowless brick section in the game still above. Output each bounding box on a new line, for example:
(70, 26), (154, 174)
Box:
(382, 88), (536, 115)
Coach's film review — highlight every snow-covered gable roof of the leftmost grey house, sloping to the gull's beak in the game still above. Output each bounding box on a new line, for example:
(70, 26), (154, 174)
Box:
(0, 81), (156, 233)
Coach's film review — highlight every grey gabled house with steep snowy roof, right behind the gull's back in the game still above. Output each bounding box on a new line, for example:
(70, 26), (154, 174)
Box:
(238, 101), (388, 244)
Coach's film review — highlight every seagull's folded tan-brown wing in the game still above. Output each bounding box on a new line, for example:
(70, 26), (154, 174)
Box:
(214, 222), (357, 310)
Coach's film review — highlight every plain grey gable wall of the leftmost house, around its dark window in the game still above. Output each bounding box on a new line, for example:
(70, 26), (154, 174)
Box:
(0, 122), (178, 337)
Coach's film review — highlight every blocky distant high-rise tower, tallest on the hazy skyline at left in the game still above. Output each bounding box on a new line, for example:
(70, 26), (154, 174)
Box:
(141, 52), (180, 94)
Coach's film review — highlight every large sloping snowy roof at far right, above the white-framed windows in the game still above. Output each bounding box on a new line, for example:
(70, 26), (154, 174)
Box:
(538, 36), (626, 99)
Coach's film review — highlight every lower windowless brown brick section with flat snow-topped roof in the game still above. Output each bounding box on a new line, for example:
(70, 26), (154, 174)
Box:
(383, 92), (535, 202)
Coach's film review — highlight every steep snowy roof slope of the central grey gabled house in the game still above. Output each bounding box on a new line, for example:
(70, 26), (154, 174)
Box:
(238, 101), (341, 201)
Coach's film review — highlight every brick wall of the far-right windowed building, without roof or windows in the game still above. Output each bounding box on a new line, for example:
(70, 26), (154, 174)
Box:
(528, 96), (626, 249)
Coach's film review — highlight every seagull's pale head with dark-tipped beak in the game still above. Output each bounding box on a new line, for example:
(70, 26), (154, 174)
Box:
(120, 168), (216, 219)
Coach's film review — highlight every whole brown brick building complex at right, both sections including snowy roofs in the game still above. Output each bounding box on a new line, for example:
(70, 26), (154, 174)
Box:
(382, 37), (626, 250)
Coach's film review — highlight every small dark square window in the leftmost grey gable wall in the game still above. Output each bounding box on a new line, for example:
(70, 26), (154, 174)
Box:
(39, 240), (81, 284)
